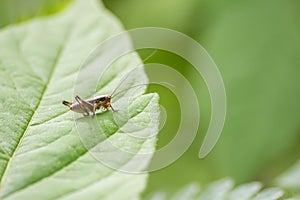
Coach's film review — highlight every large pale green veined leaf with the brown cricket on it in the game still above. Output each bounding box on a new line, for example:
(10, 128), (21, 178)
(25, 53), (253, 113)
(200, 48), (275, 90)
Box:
(0, 0), (159, 199)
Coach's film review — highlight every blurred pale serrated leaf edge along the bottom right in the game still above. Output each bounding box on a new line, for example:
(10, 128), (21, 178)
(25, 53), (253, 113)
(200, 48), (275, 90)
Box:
(145, 161), (300, 200)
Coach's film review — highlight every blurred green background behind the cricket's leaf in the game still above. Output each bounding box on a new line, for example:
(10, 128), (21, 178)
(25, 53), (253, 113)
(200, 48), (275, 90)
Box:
(0, 0), (300, 196)
